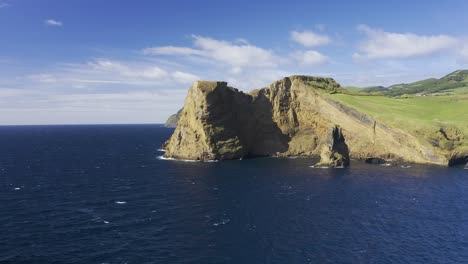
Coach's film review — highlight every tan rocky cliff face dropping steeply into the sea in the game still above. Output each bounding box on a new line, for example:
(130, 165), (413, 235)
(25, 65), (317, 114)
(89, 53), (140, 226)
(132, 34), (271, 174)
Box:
(164, 76), (454, 165)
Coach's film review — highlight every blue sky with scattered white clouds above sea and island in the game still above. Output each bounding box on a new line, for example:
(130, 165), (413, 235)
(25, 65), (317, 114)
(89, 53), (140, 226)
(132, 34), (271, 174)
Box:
(0, 0), (468, 125)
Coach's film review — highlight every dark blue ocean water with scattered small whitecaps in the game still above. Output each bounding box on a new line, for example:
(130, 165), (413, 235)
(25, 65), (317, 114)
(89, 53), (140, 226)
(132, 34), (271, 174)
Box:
(0, 125), (468, 264)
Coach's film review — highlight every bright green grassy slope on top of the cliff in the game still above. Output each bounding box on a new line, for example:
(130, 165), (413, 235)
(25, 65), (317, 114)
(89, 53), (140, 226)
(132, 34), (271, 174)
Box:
(328, 92), (468, 151)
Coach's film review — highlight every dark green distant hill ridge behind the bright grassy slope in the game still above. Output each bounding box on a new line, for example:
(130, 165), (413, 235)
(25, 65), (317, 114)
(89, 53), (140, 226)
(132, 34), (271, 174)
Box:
(349, 70), (468, 97)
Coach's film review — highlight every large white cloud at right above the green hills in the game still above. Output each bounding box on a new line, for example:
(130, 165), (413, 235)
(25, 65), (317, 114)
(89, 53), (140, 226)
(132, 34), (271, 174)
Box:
(353, 25), (459, 59)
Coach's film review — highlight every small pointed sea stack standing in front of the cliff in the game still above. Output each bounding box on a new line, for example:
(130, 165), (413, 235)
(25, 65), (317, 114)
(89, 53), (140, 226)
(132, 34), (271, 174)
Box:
(316, 126), (349, 168)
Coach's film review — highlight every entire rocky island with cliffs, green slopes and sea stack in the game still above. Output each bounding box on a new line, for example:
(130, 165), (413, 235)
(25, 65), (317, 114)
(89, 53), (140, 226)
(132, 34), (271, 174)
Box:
(162, 71), (468, 167)
